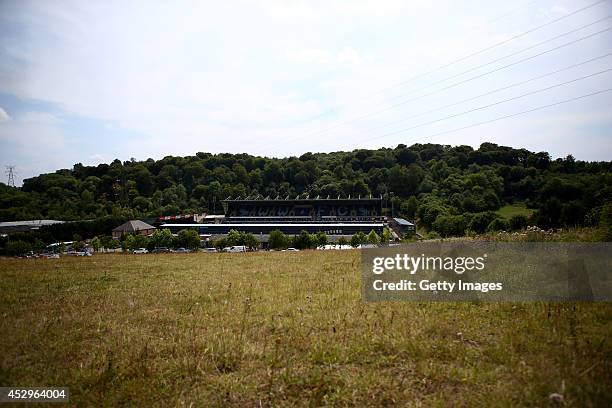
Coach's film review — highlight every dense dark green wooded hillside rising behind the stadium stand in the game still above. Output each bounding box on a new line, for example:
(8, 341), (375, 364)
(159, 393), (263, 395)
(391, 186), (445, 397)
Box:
(0, 143), (612, 235)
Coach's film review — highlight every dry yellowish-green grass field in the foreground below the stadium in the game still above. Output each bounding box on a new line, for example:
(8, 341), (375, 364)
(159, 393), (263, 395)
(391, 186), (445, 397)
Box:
(0, 250), (612, 407)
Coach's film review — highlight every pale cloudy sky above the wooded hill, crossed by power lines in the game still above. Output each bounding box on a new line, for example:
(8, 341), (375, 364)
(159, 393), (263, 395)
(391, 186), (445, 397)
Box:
(0, 0), (612, 185)
